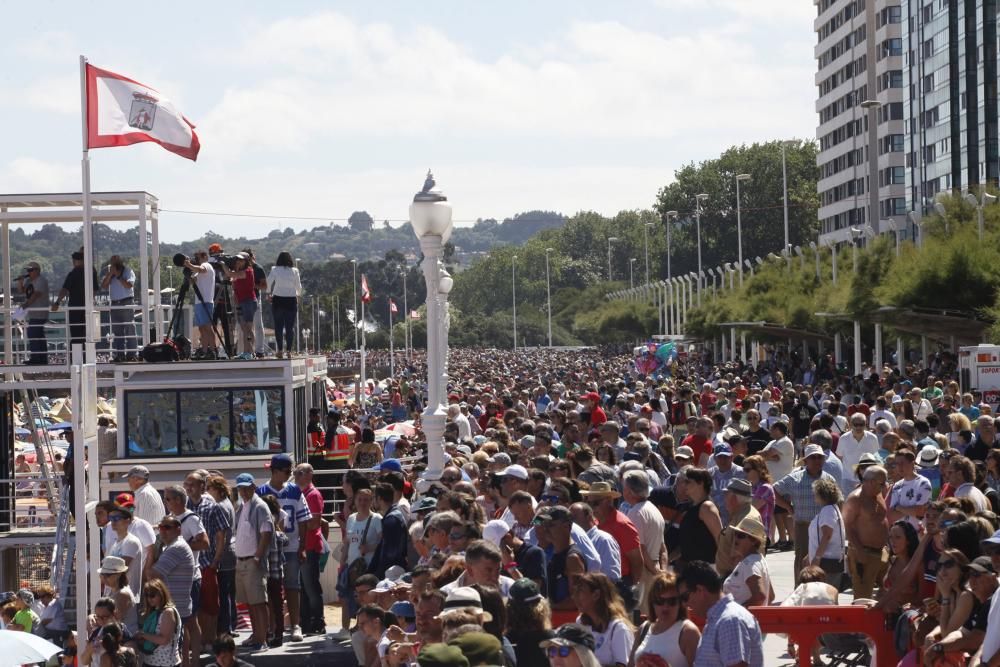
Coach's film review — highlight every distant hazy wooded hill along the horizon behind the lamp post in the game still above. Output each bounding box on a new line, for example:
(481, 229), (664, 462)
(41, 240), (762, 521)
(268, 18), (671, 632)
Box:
(10, 211), (566, 284)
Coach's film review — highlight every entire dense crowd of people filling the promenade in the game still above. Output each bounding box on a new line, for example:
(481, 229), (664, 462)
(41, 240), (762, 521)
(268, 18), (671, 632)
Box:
(10, 349), (1000, 667)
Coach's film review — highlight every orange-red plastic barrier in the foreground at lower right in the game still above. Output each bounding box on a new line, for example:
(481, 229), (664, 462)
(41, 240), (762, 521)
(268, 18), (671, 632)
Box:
(750, 605), (899, 667)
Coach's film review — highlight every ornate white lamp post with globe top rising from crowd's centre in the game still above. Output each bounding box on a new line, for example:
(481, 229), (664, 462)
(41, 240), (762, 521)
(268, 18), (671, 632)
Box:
(410, 171), (453, 480)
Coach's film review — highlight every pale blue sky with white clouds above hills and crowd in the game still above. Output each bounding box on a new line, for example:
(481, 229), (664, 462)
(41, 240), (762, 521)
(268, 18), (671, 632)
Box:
(0, 0), (816, 241)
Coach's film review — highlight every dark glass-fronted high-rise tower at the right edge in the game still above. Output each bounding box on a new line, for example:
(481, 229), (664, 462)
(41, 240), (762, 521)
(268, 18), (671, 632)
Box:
(902, 0), (1000, 213)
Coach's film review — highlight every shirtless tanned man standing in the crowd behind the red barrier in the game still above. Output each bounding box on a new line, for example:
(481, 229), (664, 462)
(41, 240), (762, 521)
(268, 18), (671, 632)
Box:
(844, 466), (889, 599)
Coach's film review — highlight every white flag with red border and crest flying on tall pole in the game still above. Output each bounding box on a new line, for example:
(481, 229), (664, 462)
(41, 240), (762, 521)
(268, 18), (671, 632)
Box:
(86, 64), (201, 160)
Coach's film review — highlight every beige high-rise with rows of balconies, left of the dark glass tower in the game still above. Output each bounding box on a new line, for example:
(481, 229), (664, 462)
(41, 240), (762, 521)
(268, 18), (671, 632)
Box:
(815, 0), (908, 242)
